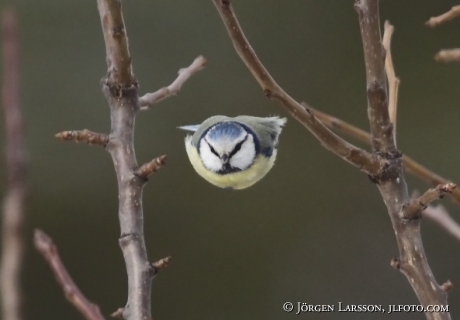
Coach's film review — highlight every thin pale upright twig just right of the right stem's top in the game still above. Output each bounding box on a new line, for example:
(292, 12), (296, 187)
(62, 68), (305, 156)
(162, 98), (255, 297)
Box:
(382, 20), (400, 130)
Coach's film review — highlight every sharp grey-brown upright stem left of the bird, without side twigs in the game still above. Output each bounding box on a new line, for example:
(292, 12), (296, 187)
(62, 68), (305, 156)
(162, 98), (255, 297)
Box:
(97, 0), (155, 320)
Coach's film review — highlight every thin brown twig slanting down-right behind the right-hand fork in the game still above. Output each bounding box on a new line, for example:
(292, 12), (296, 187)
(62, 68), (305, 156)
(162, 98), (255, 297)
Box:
(302, 102), (460, 204)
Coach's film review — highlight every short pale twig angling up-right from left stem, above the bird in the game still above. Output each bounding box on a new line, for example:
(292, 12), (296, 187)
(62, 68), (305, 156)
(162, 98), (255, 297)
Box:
(139, 56), (206, 110)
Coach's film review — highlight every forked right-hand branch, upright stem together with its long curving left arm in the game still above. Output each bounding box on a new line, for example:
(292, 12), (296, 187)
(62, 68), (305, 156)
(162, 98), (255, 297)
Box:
(213, 0), (450, 319)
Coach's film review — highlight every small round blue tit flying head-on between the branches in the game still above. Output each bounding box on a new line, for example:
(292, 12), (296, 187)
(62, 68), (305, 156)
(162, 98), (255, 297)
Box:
(180, 116), (286, 189)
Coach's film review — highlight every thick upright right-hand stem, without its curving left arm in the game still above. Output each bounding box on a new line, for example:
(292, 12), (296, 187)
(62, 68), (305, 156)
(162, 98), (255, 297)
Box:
(355, 0), (450, 320)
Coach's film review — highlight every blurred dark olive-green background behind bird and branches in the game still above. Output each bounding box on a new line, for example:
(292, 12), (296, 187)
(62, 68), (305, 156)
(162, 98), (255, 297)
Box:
(0, 0), (460, 320)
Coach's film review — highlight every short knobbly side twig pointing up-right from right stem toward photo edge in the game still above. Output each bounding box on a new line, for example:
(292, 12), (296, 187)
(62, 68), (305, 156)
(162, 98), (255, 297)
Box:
(400, 183), (457, 219)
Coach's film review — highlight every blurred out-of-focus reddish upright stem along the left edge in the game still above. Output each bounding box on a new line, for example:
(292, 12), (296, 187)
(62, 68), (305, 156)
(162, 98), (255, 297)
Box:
(0, 9), (26, 320)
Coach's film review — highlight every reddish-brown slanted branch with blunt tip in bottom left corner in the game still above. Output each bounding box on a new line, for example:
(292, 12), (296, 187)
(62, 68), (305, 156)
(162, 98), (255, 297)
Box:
(34, 230), (104, 320)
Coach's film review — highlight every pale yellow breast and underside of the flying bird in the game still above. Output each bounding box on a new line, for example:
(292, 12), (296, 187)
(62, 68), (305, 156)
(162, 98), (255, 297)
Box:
(185, 136), (276, 189)
